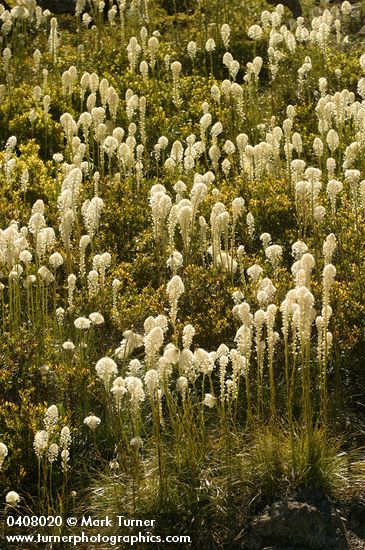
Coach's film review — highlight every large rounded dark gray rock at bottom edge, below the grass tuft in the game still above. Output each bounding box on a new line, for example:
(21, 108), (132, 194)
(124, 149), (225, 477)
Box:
(243, 499), (348, 550)
